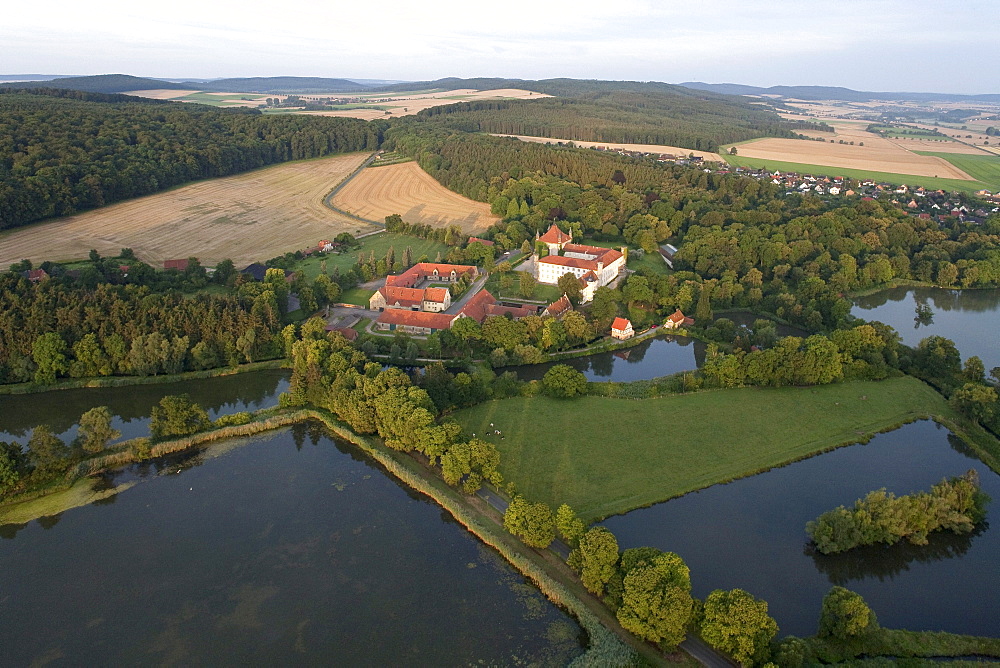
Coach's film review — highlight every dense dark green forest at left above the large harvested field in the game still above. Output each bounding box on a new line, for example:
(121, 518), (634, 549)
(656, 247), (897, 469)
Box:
(0, 89), (386, 230)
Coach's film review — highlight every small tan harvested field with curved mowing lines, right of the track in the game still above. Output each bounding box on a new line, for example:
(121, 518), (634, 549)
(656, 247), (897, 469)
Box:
(333, 162), (500, 232)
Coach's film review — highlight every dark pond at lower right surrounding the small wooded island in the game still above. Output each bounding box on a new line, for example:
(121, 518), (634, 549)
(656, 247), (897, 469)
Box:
(602, 421), (1000, 636)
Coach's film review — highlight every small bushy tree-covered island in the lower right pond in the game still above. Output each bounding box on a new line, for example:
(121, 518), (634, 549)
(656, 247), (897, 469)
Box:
(806, 469), (989, 554)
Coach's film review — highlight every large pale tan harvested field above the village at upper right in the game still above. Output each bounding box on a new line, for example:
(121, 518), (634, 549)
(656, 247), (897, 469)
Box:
(737, 121), (972, 180)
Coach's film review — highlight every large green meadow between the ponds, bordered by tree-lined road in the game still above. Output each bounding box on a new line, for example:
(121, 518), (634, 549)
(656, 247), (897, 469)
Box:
(454, 377), (953, 522)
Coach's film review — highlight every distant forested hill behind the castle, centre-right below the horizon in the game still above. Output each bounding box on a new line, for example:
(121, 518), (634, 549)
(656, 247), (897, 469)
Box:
(408, 91), (820, 152)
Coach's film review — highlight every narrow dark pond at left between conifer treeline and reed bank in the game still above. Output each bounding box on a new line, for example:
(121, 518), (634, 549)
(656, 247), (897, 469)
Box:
(0, 369), (291, 443)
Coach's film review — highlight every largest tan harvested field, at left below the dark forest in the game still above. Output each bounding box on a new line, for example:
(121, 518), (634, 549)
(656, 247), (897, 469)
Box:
(0, 153), (376, 266)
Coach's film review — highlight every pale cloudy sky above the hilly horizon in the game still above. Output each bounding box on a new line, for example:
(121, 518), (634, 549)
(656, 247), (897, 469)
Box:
(0, 0), (1000, 93)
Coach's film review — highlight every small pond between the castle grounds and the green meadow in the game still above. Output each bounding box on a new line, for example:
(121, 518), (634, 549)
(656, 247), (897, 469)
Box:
(504, 336), (705, 382)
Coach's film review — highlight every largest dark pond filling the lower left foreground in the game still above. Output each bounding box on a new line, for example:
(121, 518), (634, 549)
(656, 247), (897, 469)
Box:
(0, 425), (582, 665)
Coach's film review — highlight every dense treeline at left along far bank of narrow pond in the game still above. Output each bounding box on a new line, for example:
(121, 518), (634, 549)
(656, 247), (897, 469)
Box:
(0, 269), (288, 383)
